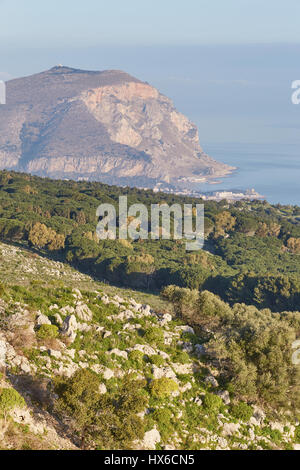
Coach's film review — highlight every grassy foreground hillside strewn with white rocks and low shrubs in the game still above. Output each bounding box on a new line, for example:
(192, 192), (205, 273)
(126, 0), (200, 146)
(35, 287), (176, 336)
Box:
(0, 244), (300, 450)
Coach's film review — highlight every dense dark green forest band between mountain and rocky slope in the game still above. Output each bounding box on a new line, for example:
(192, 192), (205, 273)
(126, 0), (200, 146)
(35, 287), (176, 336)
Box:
(0, 171), (300, 312)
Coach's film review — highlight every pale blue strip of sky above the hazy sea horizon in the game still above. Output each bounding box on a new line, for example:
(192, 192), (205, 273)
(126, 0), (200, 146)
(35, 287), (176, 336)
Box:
(0, 0), (300, 47)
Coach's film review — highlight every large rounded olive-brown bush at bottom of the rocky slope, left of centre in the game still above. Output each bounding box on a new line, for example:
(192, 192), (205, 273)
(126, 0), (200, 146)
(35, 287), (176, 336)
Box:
(55, 369), (148, 449)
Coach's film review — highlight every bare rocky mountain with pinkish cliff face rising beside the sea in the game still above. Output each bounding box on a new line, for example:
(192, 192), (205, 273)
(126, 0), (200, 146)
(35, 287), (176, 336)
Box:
(0, 66), (232, 187)
